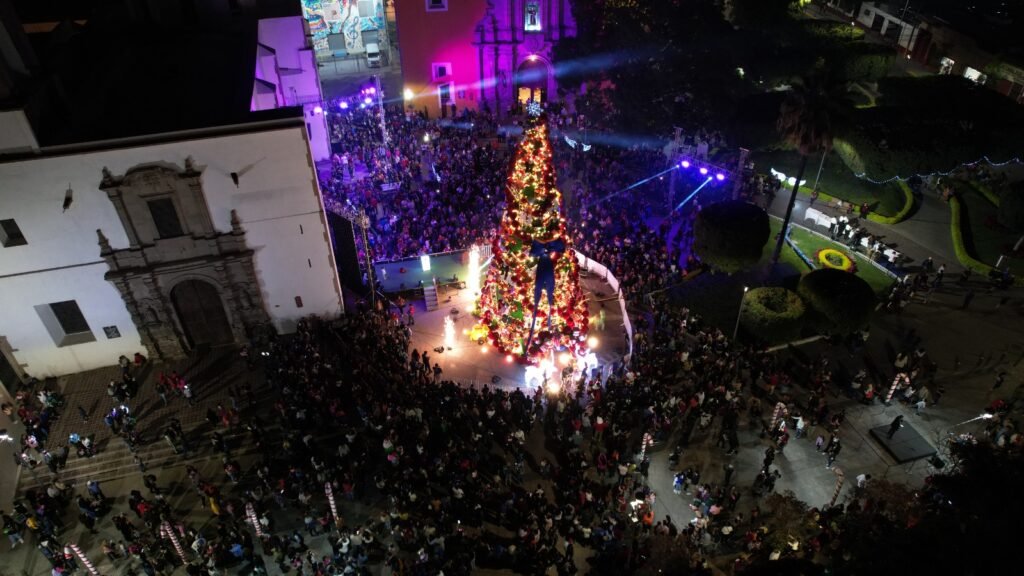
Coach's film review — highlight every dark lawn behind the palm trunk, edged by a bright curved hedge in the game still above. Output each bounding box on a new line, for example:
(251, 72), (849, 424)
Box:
(751, 150), (904, 216)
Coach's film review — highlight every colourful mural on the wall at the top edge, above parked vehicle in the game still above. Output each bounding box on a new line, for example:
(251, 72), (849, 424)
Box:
(302, 0), (386, 53)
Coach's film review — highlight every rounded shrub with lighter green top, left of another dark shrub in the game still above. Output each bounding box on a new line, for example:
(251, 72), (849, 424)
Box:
(739, 288), (806, 344)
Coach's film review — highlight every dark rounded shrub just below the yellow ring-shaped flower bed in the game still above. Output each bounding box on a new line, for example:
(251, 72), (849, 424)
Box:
(797, 269), (876, 334)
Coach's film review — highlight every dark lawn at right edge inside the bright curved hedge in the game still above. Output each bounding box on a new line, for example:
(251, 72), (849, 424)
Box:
(955, 182), (1024, 278)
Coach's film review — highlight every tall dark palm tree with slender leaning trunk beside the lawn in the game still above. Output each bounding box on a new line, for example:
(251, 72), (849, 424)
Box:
(771, 74), (836, 264)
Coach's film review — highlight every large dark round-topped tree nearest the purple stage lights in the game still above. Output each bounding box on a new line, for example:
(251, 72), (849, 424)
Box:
(693, 200), (771, 274)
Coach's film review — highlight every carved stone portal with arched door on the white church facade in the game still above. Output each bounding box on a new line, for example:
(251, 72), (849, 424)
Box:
(97, 162), (269, 359)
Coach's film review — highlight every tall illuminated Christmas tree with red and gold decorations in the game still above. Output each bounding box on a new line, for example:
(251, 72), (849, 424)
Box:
(476, 106), (588, 363)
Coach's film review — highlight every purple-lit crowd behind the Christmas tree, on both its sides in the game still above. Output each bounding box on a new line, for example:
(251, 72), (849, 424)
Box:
(322, 97), (733, 305)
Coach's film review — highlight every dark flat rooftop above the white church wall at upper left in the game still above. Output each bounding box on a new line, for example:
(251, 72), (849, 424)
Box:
(6, 0), (302, 148)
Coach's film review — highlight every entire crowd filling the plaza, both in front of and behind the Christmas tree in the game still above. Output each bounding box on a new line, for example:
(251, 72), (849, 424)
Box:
(2, 89), (1020, 575)
